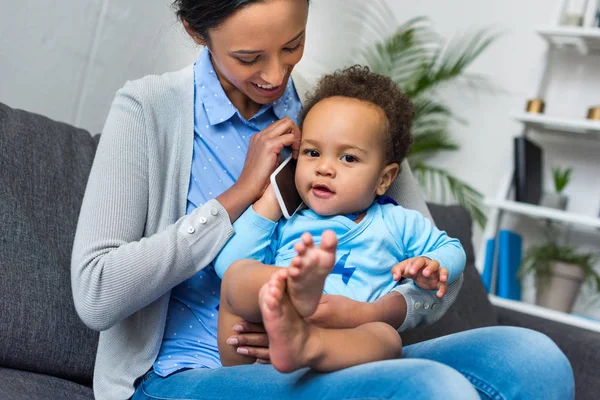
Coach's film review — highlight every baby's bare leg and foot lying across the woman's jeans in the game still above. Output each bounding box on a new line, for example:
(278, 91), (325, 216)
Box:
(259, 270), (402, 372)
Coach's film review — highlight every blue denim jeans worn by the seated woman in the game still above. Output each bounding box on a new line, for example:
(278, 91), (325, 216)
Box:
(133, 327), (575, 400)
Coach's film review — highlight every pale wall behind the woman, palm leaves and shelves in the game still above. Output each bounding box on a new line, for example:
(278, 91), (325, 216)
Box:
(0, 0), (600, 312)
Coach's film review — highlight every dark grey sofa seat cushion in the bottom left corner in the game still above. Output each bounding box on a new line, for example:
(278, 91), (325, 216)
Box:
(0, 368), (94, 400)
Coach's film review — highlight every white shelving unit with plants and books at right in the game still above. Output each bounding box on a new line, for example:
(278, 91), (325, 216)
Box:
(476, 0), (600, 332)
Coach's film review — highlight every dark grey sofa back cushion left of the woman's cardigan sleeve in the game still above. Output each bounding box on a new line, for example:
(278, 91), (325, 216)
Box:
(0, 103), (97, 386)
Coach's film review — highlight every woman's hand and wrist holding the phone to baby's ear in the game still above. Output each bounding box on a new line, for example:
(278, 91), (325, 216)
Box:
(217, 117), (300, 222)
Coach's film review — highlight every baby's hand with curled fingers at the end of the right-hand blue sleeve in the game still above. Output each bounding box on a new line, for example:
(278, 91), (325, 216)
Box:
(392, 257), (448, 298)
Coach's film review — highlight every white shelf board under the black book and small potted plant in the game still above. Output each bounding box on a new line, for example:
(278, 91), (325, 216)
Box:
(484, 198), (600, 228)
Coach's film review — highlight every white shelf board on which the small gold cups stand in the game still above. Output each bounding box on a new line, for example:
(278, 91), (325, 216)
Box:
(511, 112), (600, 139)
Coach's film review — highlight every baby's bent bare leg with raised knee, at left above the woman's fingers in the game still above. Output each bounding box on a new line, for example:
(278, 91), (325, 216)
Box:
(217, 260), (281, 366)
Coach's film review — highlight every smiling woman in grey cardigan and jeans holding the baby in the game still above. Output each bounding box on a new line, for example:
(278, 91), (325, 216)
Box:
(72, 0), (573, 399)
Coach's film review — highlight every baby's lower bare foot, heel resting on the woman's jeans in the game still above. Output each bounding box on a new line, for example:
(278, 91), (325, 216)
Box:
(258, 269), (318, 372)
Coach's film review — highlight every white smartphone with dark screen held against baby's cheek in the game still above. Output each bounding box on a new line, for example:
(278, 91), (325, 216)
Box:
(271, 155), (302, 219)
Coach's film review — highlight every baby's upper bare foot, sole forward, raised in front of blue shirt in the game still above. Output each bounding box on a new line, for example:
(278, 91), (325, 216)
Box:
(287, 231), (337, 318)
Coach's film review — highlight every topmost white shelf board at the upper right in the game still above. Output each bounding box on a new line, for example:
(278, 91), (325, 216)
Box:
(537, 26), (600, 54)
